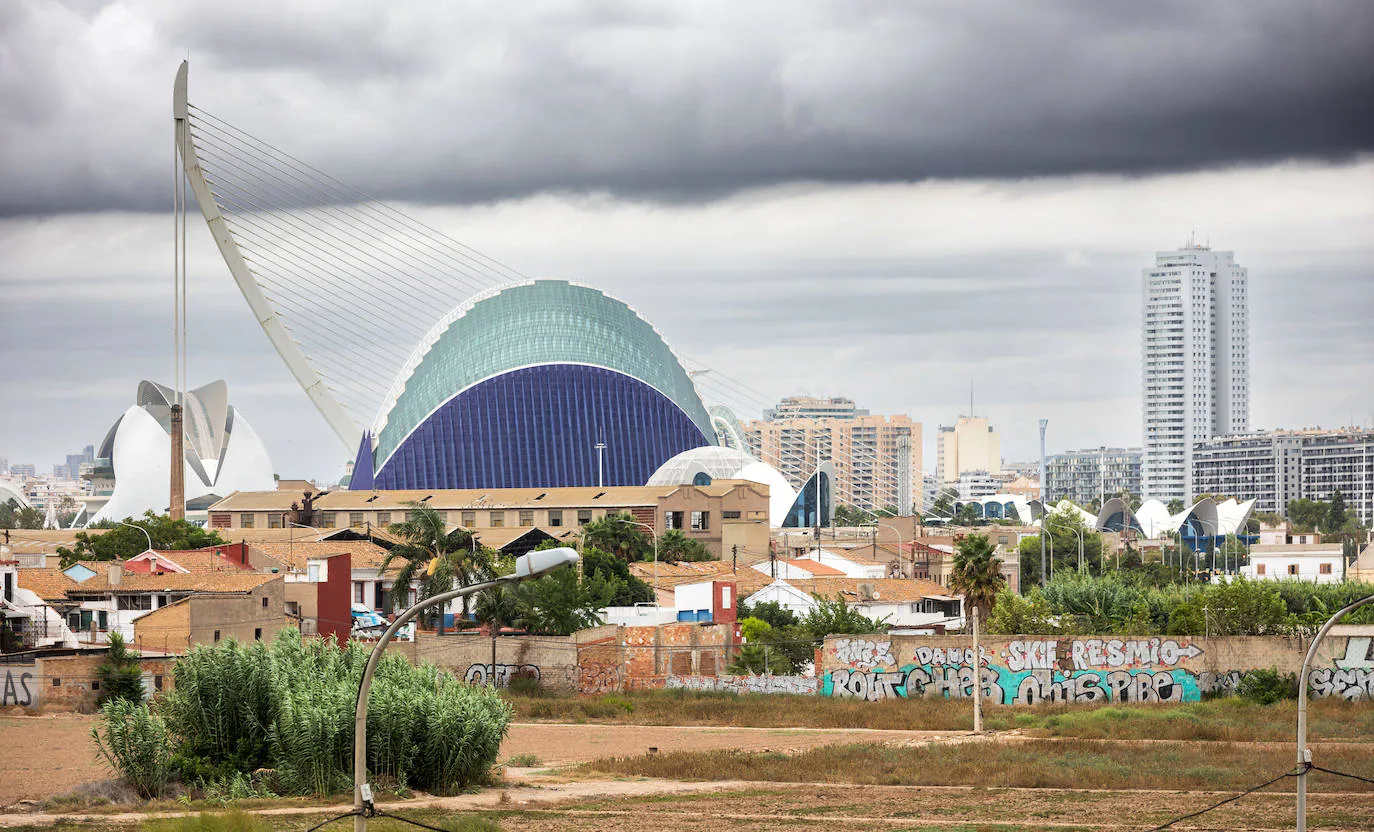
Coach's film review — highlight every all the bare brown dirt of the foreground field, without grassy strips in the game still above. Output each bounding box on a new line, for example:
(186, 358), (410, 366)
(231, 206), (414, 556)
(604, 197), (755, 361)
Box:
(0, 714), (1374, 832)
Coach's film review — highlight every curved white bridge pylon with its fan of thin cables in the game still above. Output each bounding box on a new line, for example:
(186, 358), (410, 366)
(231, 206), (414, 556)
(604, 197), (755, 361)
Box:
(172, 62), (525, 452)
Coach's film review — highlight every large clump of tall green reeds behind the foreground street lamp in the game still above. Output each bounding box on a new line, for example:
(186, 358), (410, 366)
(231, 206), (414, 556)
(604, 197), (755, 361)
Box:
(94, 630), (511, 795)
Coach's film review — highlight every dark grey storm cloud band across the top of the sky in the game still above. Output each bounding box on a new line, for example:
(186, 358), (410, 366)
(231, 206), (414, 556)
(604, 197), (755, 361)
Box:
(0, 0), (1374, 216)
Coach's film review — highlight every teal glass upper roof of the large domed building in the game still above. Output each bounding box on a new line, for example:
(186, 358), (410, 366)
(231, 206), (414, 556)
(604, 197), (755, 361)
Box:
(375, 280), (716, 468)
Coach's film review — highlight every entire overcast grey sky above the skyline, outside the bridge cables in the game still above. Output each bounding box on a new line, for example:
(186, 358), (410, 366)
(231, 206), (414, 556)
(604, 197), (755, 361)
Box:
(0, 0), (1374, 478)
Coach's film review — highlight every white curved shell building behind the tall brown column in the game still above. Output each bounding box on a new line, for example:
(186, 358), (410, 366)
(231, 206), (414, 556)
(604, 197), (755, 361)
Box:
(91, 382), (276, 522)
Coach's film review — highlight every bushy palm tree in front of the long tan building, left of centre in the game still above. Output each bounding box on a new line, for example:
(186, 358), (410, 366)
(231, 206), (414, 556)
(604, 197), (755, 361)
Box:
(379, 502), (495, 626)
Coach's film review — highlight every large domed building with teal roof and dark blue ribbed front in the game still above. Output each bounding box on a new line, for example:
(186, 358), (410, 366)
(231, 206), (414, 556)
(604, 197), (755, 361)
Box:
(349, 280), (717, 490)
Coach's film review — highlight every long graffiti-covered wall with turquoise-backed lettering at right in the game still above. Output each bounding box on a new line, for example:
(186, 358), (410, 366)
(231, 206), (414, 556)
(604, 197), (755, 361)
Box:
(818, 627), (1374, 704)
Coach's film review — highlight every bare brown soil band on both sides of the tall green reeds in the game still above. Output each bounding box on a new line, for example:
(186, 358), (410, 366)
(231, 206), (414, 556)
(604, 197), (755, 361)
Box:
(0, 714), (954, 806)
